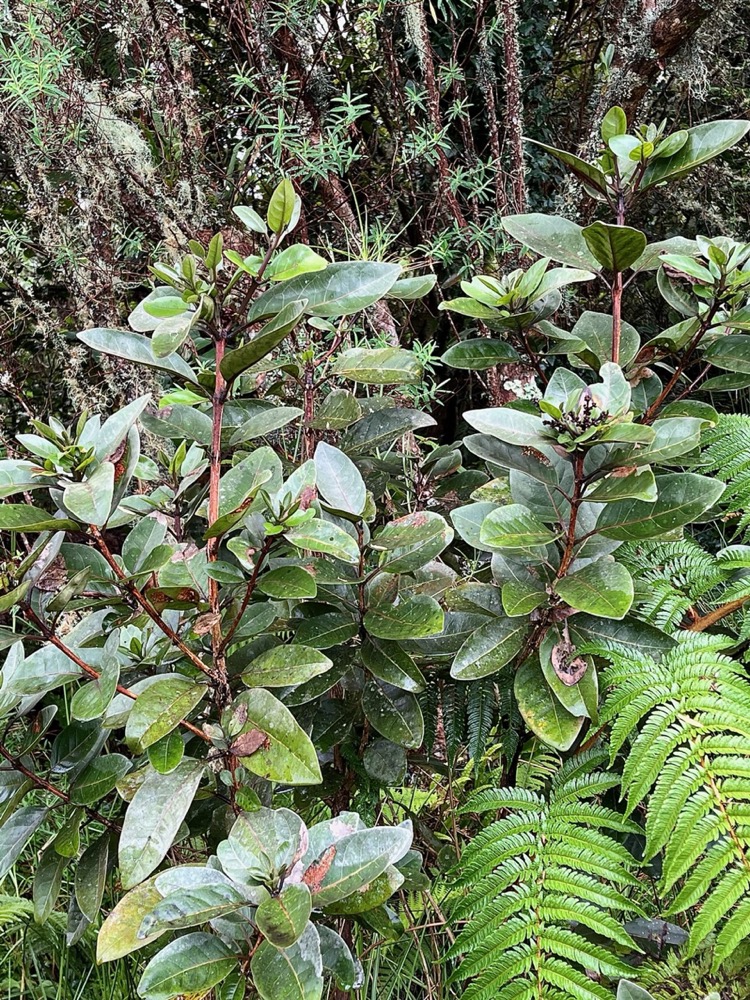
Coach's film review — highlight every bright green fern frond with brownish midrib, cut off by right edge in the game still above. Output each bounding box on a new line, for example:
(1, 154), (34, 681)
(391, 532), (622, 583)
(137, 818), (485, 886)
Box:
(602, 632), (750, 967)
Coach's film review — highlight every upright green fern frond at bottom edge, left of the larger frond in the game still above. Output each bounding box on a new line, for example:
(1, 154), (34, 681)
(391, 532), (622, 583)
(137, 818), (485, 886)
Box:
(446, 750), (643, 1000)
